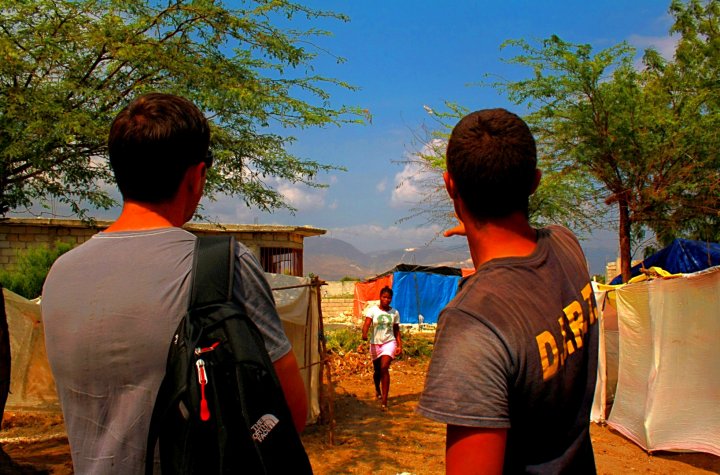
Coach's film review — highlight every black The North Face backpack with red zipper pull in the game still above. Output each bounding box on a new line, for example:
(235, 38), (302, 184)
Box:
(145, 236), (312, 475)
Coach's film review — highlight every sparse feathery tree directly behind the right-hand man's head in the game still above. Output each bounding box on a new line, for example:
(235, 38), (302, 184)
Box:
(403, 102), (602, 238)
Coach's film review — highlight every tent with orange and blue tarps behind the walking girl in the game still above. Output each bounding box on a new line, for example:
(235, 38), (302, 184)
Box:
(353, 264), (472, 324)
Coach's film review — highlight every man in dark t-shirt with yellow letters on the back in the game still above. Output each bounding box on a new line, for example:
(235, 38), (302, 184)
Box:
(418, 109), (598, 474)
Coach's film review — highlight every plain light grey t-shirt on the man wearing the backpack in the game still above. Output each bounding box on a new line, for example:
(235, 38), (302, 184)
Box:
(42, 228), (291, 475)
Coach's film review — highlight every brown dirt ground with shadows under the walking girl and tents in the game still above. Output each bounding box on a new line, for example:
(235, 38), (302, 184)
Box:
(0, 360), (720, 475)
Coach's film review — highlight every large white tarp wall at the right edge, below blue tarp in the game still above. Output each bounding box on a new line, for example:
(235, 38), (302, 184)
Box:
(608, 267), (720, 456)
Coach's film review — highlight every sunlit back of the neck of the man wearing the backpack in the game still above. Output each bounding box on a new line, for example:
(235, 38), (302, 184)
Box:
(105, 200), (185, 232)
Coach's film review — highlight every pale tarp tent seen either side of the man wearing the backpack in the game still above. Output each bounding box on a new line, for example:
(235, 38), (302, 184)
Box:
(3, 274), (321, 423)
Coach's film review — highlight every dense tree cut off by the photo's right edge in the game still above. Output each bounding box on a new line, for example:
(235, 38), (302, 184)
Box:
(646, 0), (720, 244)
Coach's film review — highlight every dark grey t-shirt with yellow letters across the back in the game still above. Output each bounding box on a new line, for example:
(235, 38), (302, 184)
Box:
(417, 226), (598, 473)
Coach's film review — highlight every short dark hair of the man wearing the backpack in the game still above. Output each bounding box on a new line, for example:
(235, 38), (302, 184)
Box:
(108, 93), (211, 203)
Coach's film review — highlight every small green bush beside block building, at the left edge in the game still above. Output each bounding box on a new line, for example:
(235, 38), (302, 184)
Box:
(0, 242), (73, 299)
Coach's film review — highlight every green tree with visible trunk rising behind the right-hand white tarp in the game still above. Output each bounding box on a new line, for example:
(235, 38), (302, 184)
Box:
(496, 6), (720, 281)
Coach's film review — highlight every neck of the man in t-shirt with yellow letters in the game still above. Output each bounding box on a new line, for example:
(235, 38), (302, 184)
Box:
(465, 213), (537, 269)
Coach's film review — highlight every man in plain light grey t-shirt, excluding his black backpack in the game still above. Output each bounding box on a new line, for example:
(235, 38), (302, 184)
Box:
(42, 93), (307, 474)
